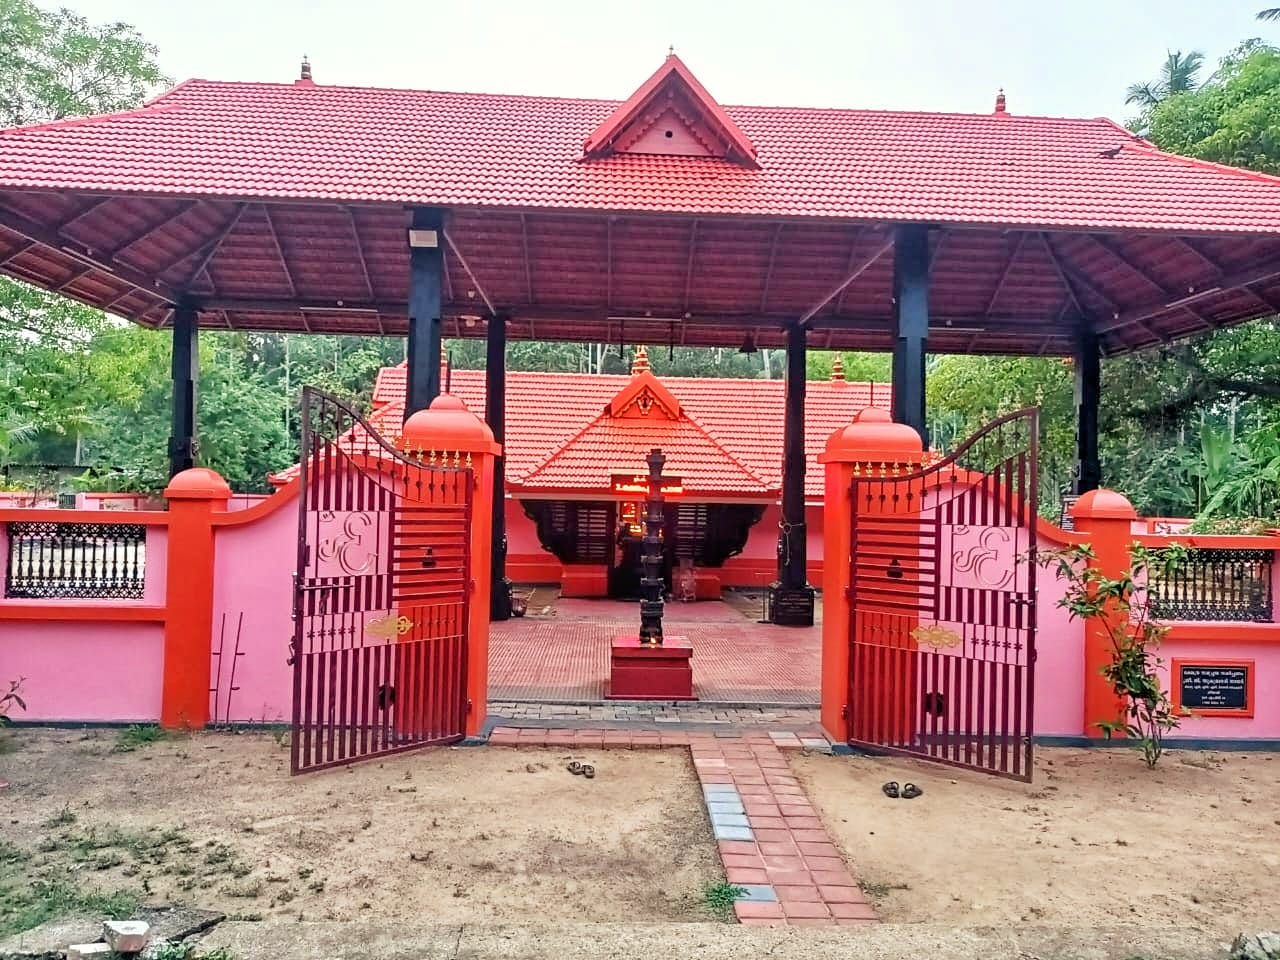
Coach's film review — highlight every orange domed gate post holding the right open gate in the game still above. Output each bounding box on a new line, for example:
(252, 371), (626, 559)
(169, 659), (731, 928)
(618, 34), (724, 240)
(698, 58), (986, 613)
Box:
(818, 408), (924, 744)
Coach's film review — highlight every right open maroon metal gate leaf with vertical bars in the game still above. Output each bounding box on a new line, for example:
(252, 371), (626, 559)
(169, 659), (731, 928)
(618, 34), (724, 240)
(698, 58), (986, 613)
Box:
(849, 410), (1038, 781)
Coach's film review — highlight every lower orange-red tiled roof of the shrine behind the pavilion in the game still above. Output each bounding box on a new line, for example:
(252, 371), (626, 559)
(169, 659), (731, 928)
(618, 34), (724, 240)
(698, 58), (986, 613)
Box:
(370, 364), (890, 500)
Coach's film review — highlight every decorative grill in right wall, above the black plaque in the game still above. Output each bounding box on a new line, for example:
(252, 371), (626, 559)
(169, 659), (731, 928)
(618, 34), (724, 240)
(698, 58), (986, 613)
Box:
(1147, 548), (1272, 623)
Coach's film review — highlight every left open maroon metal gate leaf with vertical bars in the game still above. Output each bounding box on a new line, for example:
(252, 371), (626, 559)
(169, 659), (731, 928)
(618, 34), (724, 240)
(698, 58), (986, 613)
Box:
(291, 388), (475, 773)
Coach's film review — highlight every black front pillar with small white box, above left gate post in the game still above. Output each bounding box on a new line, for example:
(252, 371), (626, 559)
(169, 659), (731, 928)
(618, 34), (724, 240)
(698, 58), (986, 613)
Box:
(404, 209), (444, 420)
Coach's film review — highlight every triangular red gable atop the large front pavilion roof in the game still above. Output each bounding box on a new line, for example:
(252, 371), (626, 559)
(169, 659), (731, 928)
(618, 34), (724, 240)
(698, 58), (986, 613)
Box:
(582, 54), (759, 166)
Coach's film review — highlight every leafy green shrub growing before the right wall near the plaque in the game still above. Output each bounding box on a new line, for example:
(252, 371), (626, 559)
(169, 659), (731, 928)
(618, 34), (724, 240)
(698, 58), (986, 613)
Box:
(1038, 544), (1187, 767)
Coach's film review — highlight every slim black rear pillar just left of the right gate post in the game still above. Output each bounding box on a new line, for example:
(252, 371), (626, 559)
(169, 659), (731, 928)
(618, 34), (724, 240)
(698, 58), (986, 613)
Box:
(769, 324), (814, 627)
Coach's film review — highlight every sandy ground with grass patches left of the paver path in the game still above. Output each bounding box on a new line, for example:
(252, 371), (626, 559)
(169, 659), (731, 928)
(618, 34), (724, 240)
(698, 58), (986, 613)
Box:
(0, 728), (723, 923)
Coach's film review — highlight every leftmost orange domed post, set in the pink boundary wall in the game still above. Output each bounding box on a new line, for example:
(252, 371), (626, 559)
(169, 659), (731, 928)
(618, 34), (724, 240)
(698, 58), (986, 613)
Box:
(160, 467), (232, 730)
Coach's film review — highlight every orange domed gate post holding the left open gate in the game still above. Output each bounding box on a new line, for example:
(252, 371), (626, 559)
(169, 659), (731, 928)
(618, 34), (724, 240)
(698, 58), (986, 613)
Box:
(401, 393), (502, 737)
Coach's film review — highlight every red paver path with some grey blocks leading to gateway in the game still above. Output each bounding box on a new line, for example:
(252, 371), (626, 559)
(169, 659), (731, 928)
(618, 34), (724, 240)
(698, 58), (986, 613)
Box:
(489, 727), (877, 927)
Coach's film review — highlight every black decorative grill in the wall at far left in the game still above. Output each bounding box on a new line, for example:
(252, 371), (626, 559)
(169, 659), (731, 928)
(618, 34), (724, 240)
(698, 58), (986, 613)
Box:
(4, 520), (147, 600)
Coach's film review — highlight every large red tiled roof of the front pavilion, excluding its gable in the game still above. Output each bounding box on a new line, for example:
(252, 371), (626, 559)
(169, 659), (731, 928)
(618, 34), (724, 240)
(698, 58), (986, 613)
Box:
(0, 69), (1280, 233)
